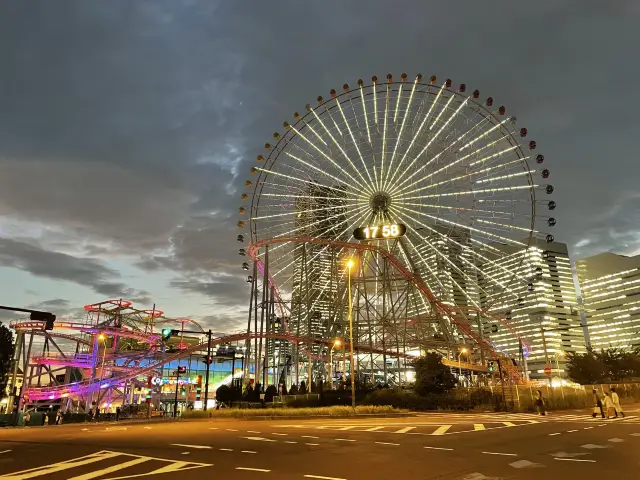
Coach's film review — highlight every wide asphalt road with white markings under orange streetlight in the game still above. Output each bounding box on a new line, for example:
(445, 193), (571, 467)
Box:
(0, 412), (640, 480)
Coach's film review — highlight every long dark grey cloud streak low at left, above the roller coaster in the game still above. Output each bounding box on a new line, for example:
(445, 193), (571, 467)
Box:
(0, 238), (148, 298)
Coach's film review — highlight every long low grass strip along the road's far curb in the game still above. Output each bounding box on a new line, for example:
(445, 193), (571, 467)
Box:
(182, 405), (402, 418)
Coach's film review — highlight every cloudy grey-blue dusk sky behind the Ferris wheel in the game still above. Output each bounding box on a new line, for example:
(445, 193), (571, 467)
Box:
(0, 0), (640, 331)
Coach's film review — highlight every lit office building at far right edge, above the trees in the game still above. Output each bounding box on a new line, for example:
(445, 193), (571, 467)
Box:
(576, 253), (640, 350)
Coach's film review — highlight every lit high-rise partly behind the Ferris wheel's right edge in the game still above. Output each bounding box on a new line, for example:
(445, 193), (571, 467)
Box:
(480, 240), (585, 379)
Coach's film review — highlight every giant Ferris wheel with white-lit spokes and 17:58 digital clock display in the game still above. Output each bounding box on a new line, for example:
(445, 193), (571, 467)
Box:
(238, 73), (556, 356)
